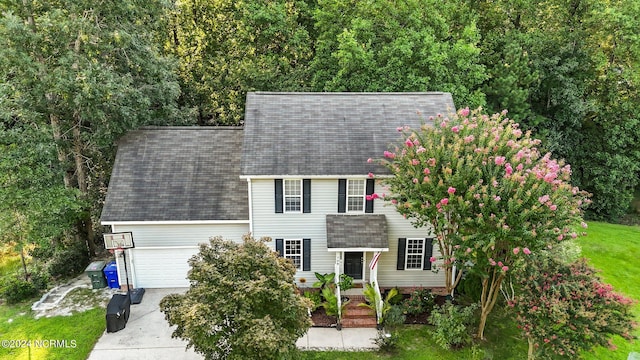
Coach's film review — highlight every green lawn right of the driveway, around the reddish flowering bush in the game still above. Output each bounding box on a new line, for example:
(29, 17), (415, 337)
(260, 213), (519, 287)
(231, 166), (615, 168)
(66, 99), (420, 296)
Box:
(302, 222), (640, 360)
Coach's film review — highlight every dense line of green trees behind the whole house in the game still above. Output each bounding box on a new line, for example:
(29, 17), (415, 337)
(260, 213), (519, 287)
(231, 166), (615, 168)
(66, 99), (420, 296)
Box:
(0, 0), (640, 278)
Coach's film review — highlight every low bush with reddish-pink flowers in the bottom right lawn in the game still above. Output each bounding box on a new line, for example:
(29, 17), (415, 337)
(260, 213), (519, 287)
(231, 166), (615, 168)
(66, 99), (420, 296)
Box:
(508, 259), (634, 359)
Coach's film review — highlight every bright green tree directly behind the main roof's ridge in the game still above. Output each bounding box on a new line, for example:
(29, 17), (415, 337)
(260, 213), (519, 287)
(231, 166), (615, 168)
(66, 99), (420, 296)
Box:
(312, 0), (486, 107)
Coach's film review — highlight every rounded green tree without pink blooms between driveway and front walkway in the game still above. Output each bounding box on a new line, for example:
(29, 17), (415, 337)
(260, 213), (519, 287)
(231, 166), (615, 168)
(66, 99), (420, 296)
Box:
(160, 235), (311, 359)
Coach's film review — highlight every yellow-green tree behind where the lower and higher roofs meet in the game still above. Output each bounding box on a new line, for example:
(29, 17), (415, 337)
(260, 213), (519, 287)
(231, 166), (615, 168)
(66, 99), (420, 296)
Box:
(167, 0), (312, 125)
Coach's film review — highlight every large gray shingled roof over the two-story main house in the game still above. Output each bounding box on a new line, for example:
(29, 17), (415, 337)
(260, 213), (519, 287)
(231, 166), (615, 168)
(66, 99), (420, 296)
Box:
(241, 92), (455, 176)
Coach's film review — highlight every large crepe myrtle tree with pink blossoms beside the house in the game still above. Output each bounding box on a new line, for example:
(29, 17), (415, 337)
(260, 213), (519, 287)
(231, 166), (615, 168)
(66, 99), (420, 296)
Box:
(371, 108), (588, 338)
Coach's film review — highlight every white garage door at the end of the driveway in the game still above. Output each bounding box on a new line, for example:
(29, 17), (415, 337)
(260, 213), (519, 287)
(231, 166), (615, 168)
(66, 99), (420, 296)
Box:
(133, 246), (198, 288)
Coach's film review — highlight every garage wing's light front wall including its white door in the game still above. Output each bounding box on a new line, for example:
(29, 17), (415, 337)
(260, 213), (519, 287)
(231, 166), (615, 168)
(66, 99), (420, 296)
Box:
(112, 224), (249, 288)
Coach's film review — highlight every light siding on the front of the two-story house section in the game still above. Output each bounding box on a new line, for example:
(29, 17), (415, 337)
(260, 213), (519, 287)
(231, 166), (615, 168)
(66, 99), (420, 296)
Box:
(250, 179), (444, 287)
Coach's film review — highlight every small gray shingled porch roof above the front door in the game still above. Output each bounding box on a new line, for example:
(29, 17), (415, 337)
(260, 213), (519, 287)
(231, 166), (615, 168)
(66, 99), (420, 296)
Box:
(326, 214), (389, 249)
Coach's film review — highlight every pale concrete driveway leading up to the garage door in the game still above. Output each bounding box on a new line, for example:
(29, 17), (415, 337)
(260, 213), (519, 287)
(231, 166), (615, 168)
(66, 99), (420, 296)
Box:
(88, 288), (203, 360)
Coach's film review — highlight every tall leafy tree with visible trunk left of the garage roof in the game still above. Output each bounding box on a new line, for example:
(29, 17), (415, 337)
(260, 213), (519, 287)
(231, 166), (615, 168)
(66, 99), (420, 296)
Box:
(0, 0), (184, 258)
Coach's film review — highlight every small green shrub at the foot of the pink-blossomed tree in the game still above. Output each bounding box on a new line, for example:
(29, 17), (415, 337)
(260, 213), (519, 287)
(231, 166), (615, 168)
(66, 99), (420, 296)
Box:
(429, 301), (478, 349)
